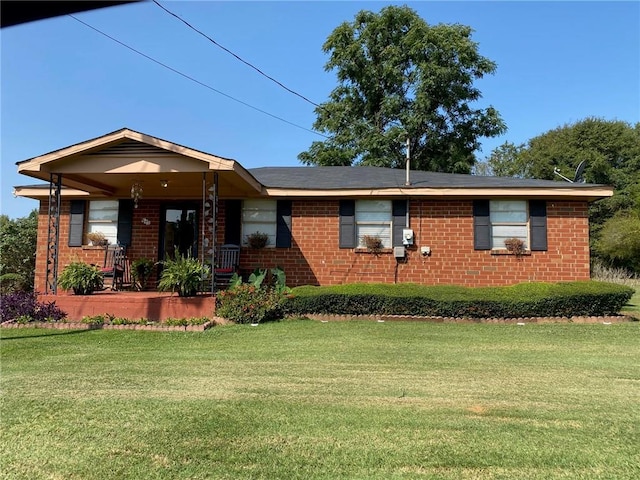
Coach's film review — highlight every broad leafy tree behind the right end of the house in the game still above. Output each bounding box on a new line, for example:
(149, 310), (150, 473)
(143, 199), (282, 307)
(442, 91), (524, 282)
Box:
(479, 118), (640, 267)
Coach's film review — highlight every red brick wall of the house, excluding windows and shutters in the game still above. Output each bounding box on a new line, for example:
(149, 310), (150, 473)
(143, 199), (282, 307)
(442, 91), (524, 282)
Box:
(36, 200), (590, 292)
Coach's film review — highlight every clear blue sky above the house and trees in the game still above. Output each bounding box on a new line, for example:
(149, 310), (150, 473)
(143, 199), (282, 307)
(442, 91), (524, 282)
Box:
(0, 1), (640, 218)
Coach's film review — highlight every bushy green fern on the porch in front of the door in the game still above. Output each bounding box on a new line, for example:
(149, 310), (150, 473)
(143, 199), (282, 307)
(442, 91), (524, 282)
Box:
(158, 253), (209, 297)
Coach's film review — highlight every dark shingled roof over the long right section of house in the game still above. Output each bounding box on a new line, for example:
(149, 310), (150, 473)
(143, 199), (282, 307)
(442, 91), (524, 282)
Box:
(249, 167), (594, 190)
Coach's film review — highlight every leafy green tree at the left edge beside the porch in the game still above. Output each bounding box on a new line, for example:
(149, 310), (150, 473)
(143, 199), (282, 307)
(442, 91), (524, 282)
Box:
(0, 210), (38, 293)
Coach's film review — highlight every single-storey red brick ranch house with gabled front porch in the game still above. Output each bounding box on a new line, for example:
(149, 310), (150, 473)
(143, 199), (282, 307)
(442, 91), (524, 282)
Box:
(15, 128), (613, 320)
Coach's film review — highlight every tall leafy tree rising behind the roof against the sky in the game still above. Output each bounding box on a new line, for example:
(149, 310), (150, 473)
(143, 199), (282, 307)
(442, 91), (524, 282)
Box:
(298, 6), (506, 173)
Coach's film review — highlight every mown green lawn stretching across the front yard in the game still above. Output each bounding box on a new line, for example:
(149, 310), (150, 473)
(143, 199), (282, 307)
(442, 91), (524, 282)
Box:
(0, 321), (640, 479)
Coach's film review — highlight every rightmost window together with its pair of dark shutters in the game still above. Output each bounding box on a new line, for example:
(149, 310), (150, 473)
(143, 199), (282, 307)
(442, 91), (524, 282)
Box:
(473, 200), (547, 251)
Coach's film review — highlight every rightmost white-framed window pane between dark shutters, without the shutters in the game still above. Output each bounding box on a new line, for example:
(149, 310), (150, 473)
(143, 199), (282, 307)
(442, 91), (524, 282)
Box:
(489, 200), (529, 249)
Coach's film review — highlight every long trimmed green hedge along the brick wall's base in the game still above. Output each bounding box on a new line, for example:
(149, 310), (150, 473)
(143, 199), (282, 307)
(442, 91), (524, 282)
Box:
(287, 281), (634, 318)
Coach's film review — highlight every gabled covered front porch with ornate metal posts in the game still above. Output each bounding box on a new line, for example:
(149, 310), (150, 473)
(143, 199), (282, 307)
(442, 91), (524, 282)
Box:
(16, 129), (262, 298)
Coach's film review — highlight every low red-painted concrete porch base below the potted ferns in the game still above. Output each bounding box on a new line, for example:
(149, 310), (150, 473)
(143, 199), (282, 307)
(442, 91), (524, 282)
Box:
(38, 290), (216, 322)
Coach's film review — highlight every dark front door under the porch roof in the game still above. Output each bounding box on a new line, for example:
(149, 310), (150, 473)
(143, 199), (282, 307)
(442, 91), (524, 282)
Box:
(159, 203), (199, 260)
